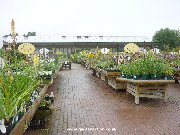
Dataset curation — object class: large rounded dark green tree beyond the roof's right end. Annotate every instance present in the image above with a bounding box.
[153,28,180,50]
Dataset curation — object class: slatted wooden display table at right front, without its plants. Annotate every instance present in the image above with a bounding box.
[126,79,175,104]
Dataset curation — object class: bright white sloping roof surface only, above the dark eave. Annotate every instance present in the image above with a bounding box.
[4,36,150,43]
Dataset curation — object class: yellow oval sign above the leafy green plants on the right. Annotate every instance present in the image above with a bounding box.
[124,43,139,54]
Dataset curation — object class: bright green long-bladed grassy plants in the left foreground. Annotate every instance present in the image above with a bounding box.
[0,67,40,120]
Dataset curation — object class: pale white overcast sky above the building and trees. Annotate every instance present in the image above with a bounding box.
[0,0,180,38]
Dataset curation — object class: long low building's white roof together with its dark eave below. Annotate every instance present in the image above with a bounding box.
[4,36,155,48]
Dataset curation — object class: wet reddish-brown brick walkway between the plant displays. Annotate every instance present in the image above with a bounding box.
[44,64,180,135]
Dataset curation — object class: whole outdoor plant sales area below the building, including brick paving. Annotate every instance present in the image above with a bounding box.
[0,21,180,135]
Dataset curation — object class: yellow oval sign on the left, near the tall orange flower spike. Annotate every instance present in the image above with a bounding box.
[18,43,35,54]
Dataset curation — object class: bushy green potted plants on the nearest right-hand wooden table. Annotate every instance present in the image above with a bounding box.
[120,53,173,75]
